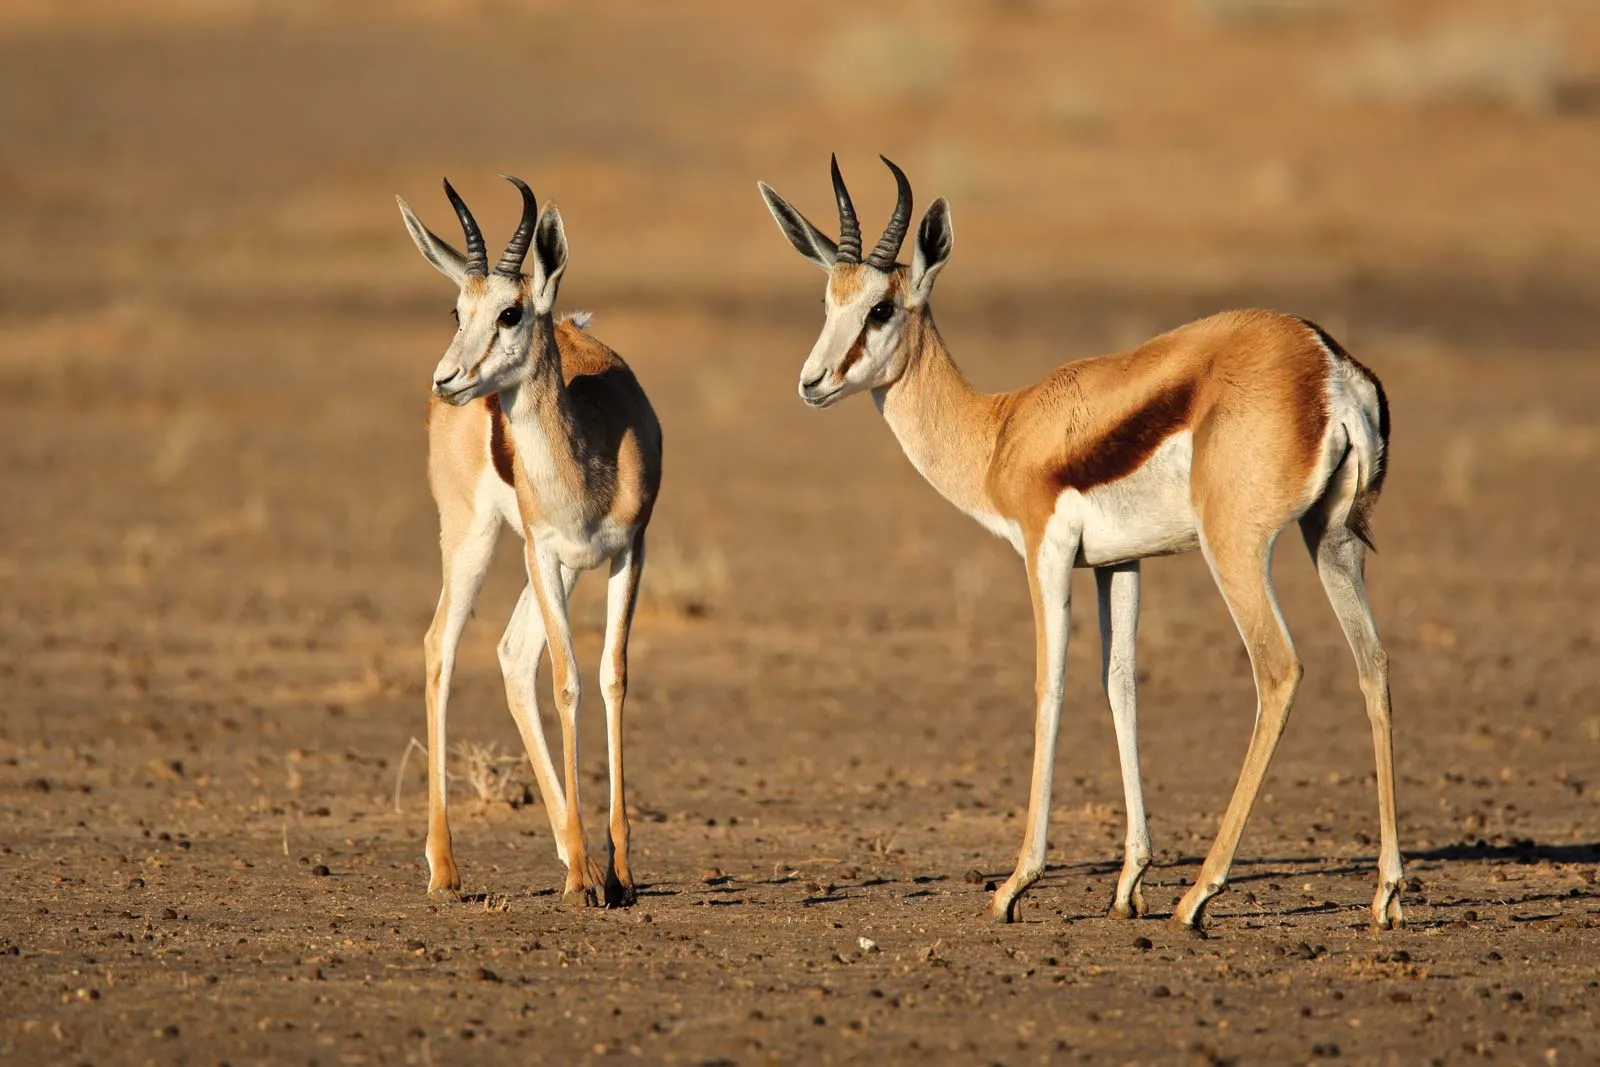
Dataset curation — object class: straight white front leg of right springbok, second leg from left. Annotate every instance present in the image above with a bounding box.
[1094,560,1150,918]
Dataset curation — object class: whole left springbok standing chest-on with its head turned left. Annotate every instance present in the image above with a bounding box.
[397,178,661,905]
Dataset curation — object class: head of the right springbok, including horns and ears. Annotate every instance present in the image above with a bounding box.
[757,157,954,408]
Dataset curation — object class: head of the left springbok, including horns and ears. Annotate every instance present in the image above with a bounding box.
[395,174,566,406]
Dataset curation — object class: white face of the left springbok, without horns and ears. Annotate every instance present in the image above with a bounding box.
[434,274,536,406]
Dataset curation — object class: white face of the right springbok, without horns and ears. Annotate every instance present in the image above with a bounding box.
[800,264,906,408]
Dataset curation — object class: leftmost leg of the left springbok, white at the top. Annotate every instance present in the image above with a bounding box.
[422,509,499,897]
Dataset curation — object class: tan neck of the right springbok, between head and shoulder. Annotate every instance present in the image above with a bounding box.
[872,310,997,514]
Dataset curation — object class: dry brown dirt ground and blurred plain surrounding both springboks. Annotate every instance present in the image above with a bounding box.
[0,0,1600,1065]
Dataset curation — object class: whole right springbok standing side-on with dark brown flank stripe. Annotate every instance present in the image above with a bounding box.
[758,158,1402,928]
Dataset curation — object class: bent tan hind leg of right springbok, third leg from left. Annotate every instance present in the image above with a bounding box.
[1173,531,1304,926]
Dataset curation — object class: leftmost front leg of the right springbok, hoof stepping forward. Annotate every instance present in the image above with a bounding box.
[989,536,1078,923]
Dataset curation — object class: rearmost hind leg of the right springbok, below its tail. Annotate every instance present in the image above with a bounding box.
[1301,517,1405,929]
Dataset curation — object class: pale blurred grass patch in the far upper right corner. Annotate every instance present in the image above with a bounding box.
[1326,22,1581,115]
